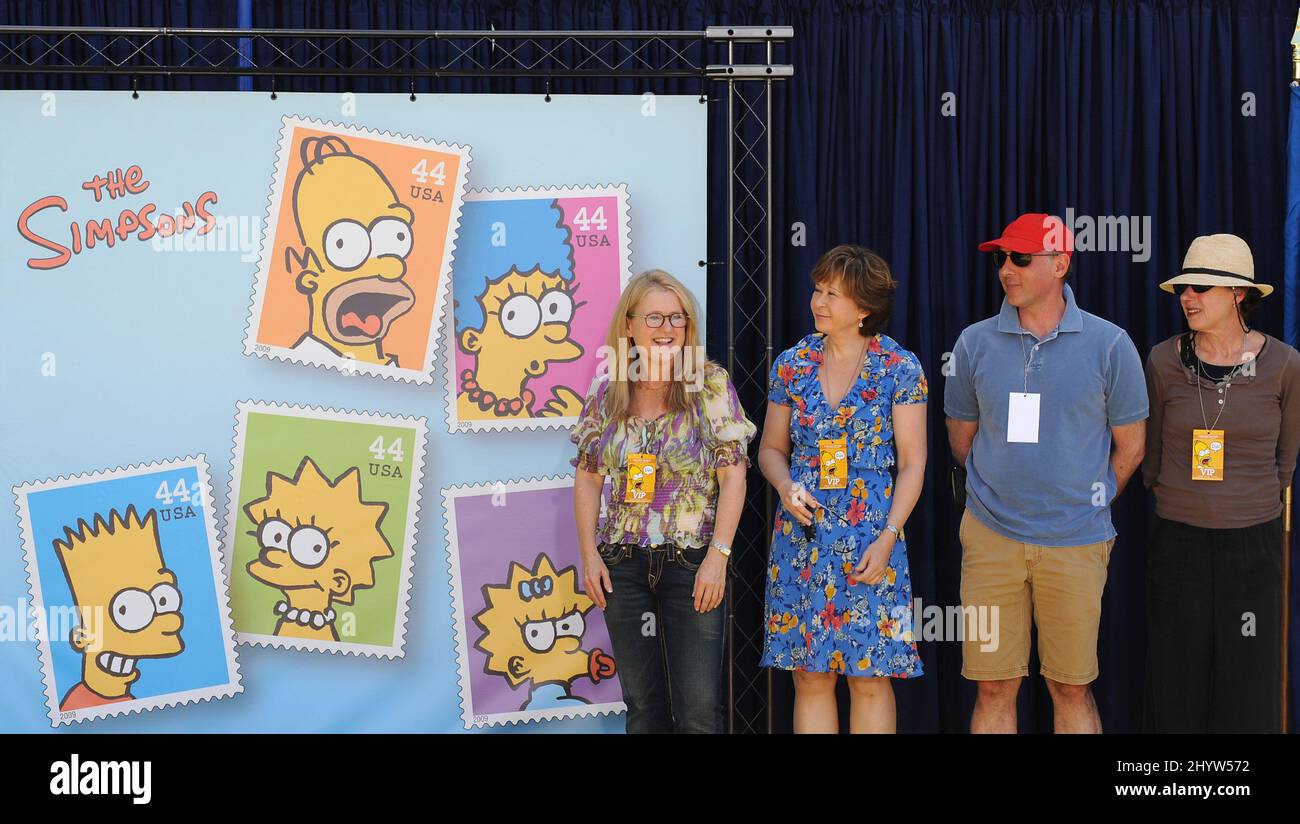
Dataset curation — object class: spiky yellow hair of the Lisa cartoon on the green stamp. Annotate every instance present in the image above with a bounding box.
[244,456,393,603]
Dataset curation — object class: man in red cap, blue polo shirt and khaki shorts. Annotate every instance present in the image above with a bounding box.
[944,214,1148,733]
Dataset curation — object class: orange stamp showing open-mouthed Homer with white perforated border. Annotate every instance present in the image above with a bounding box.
[244,117,469,383]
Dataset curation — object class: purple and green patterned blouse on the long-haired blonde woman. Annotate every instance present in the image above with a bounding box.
[569,363,758,547]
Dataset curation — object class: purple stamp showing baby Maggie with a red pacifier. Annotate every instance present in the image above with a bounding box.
[442,477,627,729]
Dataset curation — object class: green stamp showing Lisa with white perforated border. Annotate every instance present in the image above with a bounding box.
[224,402,428,658]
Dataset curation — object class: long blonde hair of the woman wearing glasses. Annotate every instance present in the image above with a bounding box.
[605,269,707,421]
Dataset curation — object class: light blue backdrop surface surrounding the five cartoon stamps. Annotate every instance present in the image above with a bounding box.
[0,92,706,732]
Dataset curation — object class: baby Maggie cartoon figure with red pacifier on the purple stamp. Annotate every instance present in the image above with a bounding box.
[475,552,615,710]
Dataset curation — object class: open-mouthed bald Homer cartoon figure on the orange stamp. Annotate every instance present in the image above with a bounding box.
[285,135,415,367]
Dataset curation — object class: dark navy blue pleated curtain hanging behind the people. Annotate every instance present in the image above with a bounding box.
[0,0,1300,732]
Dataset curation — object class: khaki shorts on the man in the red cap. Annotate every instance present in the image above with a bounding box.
[959,511,1115,684]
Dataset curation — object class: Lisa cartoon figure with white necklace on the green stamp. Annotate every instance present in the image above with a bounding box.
[244,456,393,641]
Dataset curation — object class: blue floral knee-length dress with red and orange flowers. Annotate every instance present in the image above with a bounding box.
[762,333,930,678]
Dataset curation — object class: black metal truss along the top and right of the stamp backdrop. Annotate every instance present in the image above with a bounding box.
[0,26,794,733]
